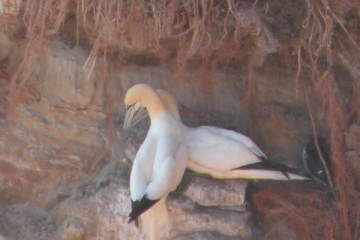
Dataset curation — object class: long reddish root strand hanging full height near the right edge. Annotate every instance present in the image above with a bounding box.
[295,0,359,240]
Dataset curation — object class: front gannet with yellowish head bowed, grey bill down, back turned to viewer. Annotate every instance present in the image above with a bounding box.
[124,84,187,227]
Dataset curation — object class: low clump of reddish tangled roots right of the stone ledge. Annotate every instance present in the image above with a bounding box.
[252,188,339,240]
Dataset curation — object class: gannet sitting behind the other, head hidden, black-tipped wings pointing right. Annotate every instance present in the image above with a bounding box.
[156,89,308,180]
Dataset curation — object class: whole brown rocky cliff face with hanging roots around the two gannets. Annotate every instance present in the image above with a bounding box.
[0,0,360,240]
